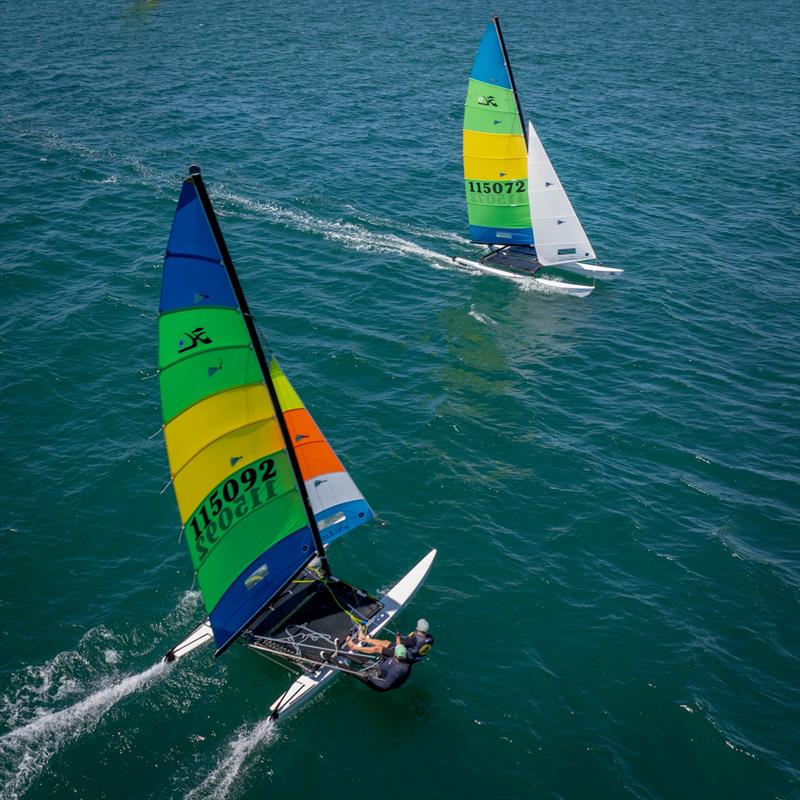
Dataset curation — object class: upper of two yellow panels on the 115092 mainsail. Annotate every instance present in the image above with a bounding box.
[164,383,275,478]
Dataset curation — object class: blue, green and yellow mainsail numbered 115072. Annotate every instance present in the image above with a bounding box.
[464,17,533,244]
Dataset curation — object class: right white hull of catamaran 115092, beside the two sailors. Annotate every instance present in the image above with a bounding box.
[262,550,436,719]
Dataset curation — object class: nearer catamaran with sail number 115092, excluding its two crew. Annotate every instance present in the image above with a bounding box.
[153,166,436,717]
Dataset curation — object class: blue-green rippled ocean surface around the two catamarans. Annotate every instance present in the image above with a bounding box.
[0,0,800,800]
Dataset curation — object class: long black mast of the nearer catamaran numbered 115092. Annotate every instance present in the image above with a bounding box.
[188,164,331,580]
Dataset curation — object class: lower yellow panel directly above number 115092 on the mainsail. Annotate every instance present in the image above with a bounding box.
[173,418,284,524]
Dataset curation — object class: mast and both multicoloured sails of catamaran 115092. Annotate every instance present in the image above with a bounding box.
[158,168,372,653]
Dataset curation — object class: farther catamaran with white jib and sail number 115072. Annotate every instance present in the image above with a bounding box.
[452,17,623,297]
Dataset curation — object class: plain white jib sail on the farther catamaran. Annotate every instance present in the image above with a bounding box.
[528,121,596,266]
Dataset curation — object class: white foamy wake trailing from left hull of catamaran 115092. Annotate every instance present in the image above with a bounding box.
[0,663,168,798]
